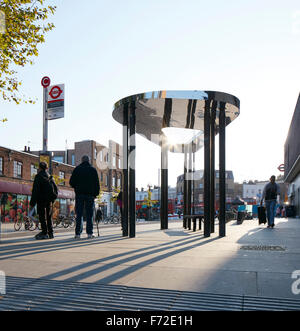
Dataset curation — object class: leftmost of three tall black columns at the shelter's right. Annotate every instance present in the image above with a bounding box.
[204,100,211,237]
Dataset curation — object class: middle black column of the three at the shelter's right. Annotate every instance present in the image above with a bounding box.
[210,101,217,233]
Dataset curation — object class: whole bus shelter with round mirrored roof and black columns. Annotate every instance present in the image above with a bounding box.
[112,90,240,237]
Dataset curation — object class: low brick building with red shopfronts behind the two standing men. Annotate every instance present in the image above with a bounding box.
[0,146,75,226]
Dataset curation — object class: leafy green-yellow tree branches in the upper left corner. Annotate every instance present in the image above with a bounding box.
[0,0,56,109]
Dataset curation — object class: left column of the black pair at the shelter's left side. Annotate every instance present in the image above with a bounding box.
[122,103,128,237]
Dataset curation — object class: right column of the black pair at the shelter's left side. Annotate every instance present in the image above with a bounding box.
[128,101,136,238]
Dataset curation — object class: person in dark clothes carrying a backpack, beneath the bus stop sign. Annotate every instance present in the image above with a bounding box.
[30,162,58,240]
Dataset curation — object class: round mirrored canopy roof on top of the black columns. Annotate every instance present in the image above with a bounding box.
[112,90,240,153]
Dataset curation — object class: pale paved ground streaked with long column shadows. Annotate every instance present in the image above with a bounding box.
[0,218,300,310]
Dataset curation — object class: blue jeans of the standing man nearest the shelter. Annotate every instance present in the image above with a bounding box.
[75,194,94,235]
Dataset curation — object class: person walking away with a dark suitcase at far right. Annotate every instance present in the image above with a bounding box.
[261,176,280,228]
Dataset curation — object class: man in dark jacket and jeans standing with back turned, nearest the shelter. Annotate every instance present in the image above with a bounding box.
[70,155,100,239]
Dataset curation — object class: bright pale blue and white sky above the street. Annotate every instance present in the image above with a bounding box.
[0,0,300,187]
